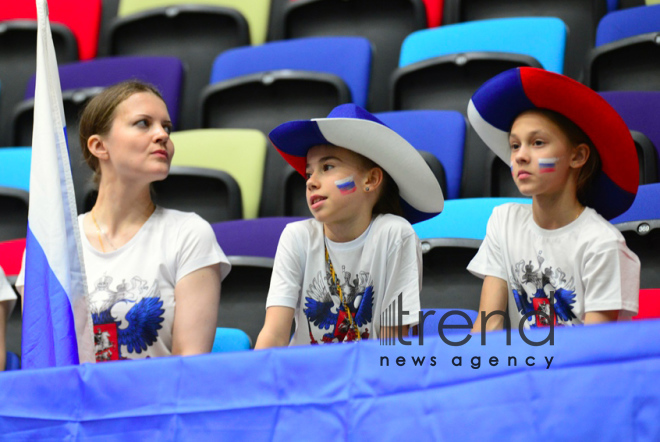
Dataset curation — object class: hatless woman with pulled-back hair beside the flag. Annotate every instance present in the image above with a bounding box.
[19,81,230,362]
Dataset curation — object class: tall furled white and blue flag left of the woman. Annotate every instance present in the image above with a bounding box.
[21,0,95,368]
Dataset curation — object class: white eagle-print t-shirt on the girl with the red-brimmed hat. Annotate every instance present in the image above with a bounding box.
[467,203,640,328]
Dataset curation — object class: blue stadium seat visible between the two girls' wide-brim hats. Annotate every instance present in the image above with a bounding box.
[376,110,466,200]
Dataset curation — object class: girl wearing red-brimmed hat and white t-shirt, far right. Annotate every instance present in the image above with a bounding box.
[468,68,640,332]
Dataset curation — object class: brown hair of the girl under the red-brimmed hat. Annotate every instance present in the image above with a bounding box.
[535,109,602,206]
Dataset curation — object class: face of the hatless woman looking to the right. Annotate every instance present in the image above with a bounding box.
[101,92,174,182]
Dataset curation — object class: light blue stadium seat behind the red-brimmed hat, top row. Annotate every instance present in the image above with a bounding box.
[390,17,567,114]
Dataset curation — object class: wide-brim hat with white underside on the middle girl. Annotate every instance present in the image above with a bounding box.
[268,104,444,223]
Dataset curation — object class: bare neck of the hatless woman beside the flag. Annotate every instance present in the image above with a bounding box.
[92,176,155,237]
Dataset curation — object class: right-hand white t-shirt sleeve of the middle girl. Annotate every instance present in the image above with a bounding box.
[383,227,422,325]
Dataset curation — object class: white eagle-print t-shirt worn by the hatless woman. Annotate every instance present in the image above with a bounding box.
[17,207,231,362]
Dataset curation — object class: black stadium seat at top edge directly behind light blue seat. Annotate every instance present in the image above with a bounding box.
[444,0,607,80]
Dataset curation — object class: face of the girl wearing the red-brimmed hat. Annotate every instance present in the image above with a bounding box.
[509,111,577,196]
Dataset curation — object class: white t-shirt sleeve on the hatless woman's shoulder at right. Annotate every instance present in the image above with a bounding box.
[175,214,231,282]
